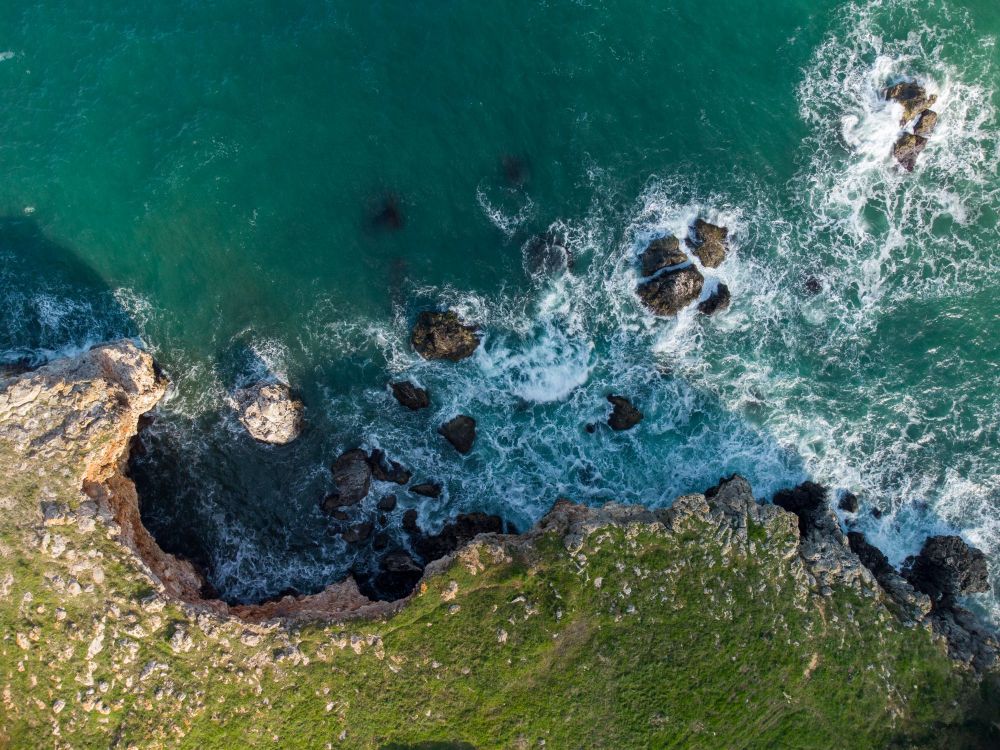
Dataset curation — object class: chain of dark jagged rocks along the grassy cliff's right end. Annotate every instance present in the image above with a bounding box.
[773,482,1000,670]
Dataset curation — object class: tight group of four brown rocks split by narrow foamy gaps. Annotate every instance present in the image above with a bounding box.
[636,219,731,317]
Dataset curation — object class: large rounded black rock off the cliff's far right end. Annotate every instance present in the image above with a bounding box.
[903,536,990,603]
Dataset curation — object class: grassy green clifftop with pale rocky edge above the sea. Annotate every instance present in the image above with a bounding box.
[0,341,998,748]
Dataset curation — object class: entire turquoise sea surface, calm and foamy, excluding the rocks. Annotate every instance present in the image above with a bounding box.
[0,0,1000,612]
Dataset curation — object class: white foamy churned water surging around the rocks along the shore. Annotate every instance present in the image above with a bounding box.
[4,0,1000,621]
